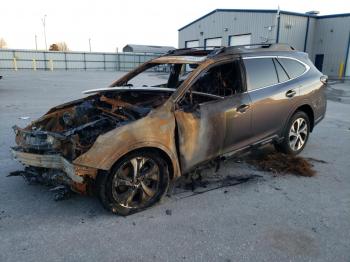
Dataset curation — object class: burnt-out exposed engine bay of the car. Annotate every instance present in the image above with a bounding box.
[13,87,175,161]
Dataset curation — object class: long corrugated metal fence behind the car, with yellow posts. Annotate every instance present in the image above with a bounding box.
[0,49,161,71]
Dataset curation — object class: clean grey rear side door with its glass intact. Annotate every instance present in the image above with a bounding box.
[244,57,299,141]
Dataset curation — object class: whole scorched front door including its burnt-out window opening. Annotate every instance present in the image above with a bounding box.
[175,61,251,173]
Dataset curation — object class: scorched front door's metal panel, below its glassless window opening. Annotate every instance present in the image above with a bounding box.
[175,61,251,172]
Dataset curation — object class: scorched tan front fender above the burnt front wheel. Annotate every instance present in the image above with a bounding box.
[73,100,180,177]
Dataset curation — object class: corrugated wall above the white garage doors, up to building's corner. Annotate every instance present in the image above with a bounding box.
[179,11,307,51]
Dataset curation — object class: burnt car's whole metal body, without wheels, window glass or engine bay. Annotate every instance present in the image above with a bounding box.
[14,44,326,193]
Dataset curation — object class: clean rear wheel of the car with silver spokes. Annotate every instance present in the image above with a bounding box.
[275,111,310,155]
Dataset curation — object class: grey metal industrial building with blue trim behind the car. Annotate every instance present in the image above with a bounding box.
[179,9,350,77]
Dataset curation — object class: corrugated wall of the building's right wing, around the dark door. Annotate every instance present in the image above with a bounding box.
[313,16,350,76]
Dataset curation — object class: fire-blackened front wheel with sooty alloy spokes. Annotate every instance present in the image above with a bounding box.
[96,150,169,216]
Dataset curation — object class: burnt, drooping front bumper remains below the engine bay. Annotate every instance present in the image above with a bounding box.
[12,147,97,193]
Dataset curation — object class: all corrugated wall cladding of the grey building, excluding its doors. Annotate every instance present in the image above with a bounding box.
[179,10,350,76]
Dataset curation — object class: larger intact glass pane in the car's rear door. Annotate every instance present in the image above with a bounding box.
[244,58,278,90]
